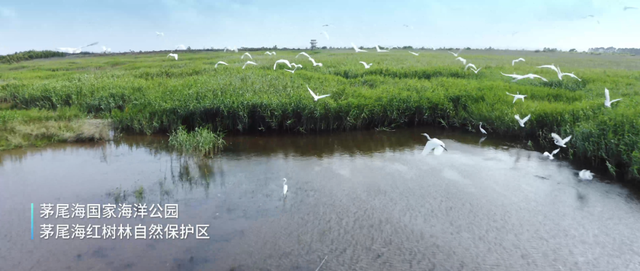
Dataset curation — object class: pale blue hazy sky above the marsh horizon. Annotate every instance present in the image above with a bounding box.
[0,0,640,55]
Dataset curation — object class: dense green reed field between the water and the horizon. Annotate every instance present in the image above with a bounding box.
[0,50,640,183]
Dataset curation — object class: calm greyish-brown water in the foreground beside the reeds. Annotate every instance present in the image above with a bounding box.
[0,128,640,271]
